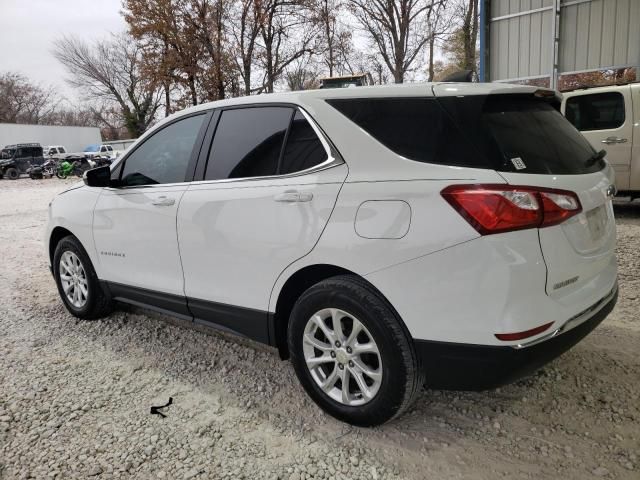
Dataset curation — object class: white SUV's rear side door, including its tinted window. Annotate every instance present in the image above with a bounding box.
[178,106,347,342]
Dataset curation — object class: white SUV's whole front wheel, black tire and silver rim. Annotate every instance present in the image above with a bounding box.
[53,235,113,320]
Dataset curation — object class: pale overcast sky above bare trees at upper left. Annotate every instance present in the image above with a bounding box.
[0,0,127,103]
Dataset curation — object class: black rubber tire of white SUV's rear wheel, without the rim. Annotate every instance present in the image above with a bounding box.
[287,275,424,427]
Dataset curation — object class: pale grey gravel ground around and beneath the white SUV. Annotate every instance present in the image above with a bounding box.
[0,179,640,480]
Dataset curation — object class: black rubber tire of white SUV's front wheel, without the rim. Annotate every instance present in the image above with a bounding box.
[53,235,113,320]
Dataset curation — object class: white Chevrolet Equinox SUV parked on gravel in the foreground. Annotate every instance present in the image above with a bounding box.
[47,84,617,425]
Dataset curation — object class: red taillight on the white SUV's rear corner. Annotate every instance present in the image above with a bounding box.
[441,185,582,235]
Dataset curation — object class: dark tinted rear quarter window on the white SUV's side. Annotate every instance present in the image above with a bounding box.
[327,98,478,167]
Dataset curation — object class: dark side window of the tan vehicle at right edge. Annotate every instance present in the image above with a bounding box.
[565,92,625,132]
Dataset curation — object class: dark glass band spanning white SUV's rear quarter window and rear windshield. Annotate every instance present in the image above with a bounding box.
[328,94,604,175]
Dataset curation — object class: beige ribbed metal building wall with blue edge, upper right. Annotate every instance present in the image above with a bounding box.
[479,0,640,88]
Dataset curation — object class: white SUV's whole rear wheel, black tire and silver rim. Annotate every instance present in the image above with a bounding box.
[288,275,423,426]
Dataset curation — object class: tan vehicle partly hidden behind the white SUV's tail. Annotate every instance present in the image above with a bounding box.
[562,83,640,198]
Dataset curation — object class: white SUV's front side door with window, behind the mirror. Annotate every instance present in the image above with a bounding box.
[93,113,208,308]
